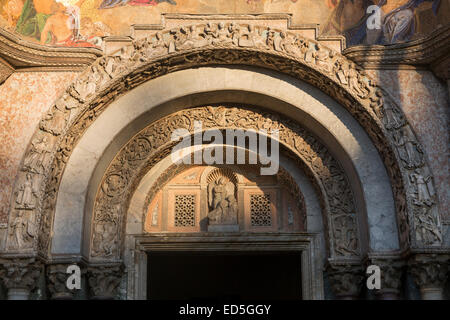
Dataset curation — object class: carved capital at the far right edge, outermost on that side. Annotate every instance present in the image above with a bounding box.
[409,254,449,300]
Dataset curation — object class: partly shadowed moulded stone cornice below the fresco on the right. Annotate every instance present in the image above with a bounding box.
[343,24,450,79]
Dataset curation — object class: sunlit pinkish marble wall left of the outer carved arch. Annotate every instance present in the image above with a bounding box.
[0,72,77,227]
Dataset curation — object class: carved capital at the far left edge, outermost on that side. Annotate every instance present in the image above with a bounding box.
[0,258,43,300]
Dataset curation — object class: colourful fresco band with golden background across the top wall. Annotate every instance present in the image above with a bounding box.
[0,0,450,47]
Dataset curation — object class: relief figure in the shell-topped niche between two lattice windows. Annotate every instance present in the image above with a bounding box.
[208,177,238,224]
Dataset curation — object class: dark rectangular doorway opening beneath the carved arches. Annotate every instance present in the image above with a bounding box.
[147,252,302,300]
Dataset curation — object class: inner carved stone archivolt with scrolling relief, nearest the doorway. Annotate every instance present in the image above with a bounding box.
[91,106,360,260]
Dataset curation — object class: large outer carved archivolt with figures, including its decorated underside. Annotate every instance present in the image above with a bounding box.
[7,22,442,255]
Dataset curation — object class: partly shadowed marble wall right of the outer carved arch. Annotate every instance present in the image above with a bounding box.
[369,70,450,221]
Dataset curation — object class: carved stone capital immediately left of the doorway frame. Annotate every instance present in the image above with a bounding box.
[87,265,124,300]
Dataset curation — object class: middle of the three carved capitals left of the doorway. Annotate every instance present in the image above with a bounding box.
[46,264,81,300]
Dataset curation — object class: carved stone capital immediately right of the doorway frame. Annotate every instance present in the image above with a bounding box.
[326,262,364,300]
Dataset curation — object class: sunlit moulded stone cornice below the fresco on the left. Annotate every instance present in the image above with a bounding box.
[0,28,103,71]
